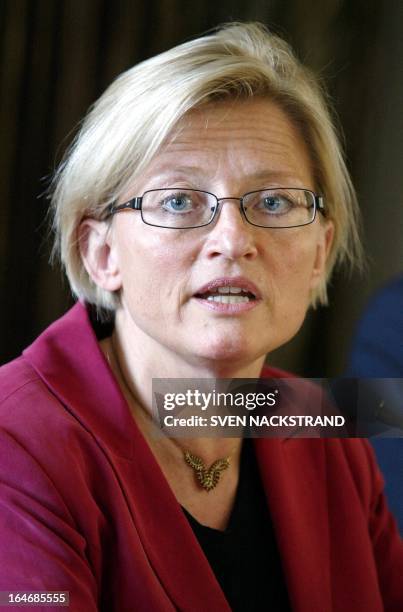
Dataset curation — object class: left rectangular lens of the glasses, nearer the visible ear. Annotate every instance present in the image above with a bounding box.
[142,187,217,229]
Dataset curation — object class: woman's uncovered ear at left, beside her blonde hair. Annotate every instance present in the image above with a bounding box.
[78,219,122,291]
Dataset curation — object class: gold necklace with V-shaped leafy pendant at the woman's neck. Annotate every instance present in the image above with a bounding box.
[106,336,238,492]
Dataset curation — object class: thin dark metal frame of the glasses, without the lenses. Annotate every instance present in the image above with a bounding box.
[104,186,326,230]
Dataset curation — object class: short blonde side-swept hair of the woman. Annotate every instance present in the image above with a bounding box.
[52,23,361,310]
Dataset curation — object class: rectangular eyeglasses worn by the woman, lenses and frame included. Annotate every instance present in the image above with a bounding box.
[105,187,325,229]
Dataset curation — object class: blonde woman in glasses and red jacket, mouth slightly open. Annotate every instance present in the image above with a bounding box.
[0,24,403,612]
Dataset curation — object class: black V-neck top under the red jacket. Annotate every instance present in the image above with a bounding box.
[183,439,291,612]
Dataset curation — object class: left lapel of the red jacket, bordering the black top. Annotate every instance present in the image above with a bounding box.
[110,420,230,612]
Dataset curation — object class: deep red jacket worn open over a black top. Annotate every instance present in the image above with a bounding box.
[0,304,403,612]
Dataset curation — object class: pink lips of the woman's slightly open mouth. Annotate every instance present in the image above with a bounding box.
[193,276,262,314]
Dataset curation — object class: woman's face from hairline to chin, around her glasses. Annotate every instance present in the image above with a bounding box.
[97,100,332,364]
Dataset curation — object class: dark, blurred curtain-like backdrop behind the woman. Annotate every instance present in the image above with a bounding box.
[0,0,403,376]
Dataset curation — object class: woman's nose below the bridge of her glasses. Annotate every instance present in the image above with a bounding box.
[205,198,257,260]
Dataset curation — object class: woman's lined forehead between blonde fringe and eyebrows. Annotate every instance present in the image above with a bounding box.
[134,99,314,188]
